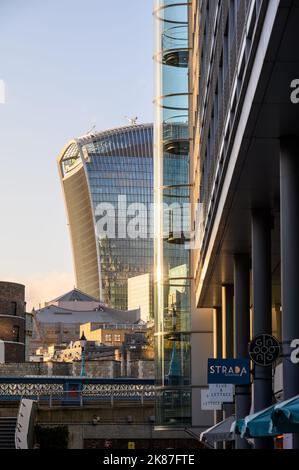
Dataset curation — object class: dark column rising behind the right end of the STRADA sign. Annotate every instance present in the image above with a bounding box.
[234,254,250,449]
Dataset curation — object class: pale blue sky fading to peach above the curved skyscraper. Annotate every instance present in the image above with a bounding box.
[0,0,153,309]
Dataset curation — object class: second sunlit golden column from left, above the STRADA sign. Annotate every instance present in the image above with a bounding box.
[222,284,234,359]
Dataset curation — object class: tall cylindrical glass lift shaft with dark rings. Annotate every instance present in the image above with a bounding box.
[154,0,191,428]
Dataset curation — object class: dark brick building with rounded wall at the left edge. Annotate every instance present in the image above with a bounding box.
[0,281,25,362]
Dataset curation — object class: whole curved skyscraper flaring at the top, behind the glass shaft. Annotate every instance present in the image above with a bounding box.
[58,124,153,310]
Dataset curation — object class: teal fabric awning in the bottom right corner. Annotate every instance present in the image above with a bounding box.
[232,395,299,438]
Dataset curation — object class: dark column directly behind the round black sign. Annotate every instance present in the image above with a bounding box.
[251,209,273,449]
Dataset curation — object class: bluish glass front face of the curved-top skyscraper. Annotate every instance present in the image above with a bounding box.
[61,125,153,309]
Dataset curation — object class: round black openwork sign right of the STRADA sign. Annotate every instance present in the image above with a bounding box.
[249,334,280,367]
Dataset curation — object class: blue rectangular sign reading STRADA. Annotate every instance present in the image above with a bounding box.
[208,359,250,385]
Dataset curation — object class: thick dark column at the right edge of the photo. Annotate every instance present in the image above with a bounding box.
[280,137,299,448]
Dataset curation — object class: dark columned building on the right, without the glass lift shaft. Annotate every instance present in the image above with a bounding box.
[189,0,299,448]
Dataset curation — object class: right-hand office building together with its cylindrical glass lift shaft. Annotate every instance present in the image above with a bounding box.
[154,0,299,448]
